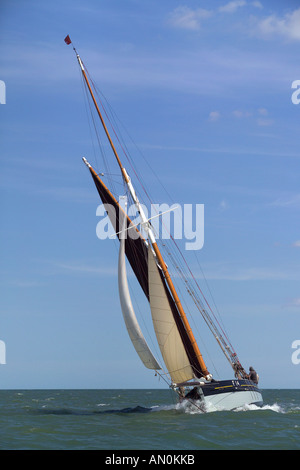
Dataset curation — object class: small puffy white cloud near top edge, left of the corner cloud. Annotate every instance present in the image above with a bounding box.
[169,6,212,30]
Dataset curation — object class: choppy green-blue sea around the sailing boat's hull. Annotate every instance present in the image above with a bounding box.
[0,390,300,452]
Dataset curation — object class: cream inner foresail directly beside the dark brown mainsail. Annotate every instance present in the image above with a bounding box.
[148,246,194,383]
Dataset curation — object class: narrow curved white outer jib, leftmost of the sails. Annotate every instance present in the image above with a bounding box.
[118,238,161,370]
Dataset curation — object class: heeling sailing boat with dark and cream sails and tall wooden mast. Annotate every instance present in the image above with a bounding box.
[65,36,263,410]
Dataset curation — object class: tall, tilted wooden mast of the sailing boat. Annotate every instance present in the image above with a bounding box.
[70,41,211,380]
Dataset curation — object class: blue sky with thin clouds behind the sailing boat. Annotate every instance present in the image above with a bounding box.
[0,0,300,388]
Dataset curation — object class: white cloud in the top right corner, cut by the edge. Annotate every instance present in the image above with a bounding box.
[258,8,300,40]
